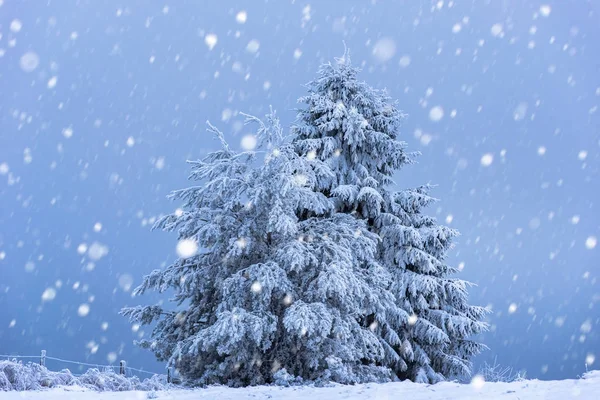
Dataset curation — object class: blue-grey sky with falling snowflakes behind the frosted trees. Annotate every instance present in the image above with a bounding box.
[0,0,600,379]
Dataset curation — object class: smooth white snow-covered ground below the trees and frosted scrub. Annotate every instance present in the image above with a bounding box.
[0,371,600,400]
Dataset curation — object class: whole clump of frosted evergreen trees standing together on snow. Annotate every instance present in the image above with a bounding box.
[122,54,487,386]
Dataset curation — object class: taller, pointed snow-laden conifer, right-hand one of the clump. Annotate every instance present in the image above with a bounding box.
[293,52,487,382]
